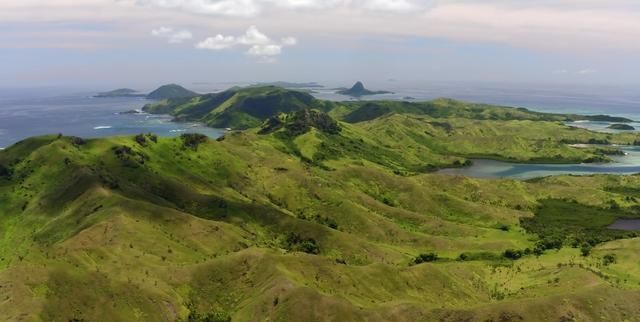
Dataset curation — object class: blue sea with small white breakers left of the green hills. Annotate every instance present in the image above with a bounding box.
[0,93,223,148]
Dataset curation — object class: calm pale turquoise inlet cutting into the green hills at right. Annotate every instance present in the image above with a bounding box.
[438,147,640,179]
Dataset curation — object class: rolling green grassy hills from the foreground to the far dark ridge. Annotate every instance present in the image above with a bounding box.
[0,91,640,322]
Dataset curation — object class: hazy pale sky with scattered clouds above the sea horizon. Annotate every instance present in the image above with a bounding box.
[0,0,640,88]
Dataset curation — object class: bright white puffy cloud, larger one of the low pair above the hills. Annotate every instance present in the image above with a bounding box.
[196,26,297,62]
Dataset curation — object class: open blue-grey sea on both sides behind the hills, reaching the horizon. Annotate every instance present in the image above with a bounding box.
[0,81,640,152]
